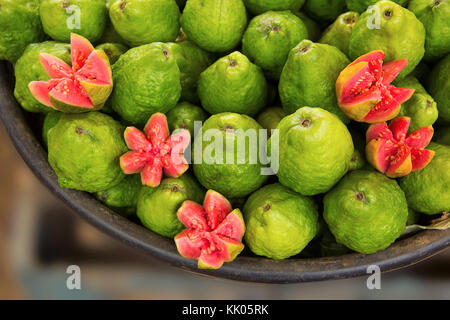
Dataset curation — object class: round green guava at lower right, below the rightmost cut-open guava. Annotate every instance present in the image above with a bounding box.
[323,170,408,254]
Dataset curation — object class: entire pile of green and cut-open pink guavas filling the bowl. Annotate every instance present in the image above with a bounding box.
[0,0,450,269]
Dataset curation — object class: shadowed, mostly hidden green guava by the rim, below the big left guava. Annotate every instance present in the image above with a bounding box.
[95,174,142,216]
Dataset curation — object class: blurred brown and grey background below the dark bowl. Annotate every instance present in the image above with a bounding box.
[0,124,450,300]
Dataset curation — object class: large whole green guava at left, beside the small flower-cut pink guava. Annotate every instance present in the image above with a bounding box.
[48,112,128,193]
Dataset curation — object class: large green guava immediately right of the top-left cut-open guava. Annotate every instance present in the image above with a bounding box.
[111,42,181,125]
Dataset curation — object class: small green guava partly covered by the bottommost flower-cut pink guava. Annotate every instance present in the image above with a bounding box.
[136,174,204,238]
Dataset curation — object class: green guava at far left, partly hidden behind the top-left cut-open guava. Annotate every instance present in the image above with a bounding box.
[14,41,70,113]
